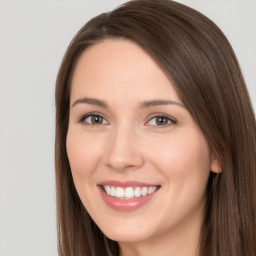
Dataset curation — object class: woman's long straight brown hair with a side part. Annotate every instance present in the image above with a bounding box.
[55,0,256,256]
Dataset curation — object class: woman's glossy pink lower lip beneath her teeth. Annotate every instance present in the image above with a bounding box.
[99,187,158,212]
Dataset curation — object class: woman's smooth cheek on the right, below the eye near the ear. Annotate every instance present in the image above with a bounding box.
[148,131,211,198]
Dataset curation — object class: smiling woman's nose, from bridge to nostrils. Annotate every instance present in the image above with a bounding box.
[105,124,144,171]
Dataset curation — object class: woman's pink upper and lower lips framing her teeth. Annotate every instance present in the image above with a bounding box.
[98,180,160,212]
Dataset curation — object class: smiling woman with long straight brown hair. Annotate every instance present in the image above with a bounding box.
[56,0,256,256]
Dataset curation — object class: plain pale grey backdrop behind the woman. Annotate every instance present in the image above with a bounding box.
[0,0,256,256]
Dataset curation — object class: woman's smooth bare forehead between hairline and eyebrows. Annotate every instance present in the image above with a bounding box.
[71,39,177,102]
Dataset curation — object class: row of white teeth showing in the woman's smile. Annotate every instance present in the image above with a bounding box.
[103,185,157,199]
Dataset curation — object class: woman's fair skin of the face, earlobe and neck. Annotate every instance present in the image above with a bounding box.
[66,39,220,256]
